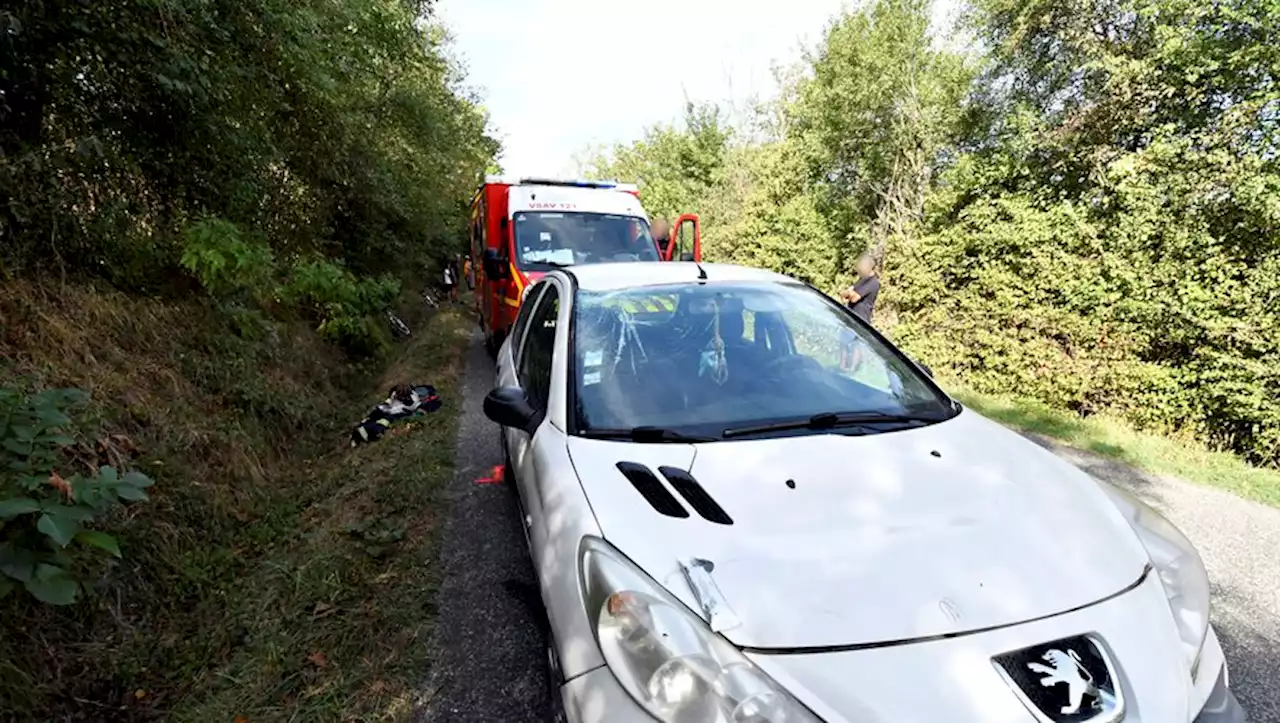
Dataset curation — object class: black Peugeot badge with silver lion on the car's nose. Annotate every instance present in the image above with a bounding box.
[992,635,1124,723]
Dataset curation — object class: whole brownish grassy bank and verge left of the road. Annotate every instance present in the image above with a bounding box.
[0,283,471,723]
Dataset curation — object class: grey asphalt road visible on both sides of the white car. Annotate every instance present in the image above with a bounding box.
[416,335,1280,723]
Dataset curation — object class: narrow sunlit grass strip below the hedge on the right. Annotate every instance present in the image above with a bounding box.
[946,383,1280,507]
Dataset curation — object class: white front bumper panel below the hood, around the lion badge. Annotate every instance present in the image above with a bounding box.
[748,575,1222,723]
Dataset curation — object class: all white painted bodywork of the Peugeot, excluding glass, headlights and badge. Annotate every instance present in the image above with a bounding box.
[495,264,1244,723]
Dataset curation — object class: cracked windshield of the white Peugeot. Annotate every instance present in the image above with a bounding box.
[572,282,955,440]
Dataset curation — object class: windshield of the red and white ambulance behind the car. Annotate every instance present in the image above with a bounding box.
[515,211,658,271]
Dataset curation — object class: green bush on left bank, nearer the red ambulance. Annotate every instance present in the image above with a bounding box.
[282,261,401,356]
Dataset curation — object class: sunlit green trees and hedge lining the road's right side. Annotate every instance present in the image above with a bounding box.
[591,0,1280,466]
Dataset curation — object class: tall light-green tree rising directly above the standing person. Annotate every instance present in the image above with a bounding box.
[794,0,970,266]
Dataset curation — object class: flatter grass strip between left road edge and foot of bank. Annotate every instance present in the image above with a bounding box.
[170,311,470,722]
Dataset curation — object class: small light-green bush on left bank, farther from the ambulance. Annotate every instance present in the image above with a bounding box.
[182,218,275,297]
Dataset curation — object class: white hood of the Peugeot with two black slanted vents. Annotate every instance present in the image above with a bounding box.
[568,411,1147,650]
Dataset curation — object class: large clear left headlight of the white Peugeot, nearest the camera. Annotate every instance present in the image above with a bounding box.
[580,537,819,723]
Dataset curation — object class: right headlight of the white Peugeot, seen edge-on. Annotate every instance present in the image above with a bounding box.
[1100,482,1210,679]
